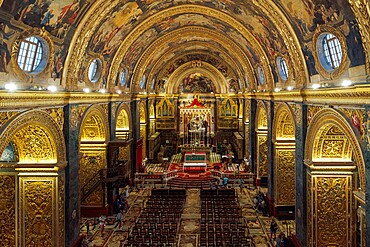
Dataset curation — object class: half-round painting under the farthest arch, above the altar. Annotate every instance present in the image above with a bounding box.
[179,73,215,93]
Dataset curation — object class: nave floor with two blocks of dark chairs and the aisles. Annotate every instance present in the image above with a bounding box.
[81,187,295,247]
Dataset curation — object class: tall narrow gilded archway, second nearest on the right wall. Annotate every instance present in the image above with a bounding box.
[272,103,296,212]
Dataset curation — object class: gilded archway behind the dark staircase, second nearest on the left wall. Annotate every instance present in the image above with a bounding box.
[79,106,109,207]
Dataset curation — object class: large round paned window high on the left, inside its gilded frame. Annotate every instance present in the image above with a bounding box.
[17,36,49,73]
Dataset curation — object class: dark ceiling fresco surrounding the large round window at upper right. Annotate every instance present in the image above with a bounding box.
[277,0,365,68]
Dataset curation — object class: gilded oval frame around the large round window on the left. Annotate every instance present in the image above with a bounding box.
[11,28,55,82]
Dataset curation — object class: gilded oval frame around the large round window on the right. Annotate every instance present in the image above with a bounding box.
[312,25,350,80]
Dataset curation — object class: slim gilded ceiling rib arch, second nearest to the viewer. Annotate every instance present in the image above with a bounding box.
[108,4,273,91]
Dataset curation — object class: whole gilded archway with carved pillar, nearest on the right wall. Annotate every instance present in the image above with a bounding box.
[305,109,365,246]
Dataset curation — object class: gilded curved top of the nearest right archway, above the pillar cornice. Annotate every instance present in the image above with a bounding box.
[304,108,365,188]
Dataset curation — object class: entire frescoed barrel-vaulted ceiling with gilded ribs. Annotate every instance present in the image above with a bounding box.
[0,0,370,93]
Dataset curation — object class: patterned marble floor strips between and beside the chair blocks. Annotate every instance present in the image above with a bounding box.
[80,188,295,247]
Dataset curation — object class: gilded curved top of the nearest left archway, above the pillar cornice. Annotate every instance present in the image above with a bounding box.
[0,110,66,165]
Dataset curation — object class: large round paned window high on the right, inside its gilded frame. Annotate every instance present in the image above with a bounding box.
[317,33,343,71]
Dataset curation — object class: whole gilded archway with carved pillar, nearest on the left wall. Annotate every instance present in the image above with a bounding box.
[0,110,66,246]
